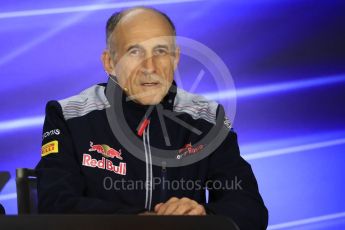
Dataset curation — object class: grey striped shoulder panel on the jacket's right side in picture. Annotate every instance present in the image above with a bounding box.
[173,88,218,124]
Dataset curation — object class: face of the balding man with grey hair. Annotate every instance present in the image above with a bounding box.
[110,10,179,105]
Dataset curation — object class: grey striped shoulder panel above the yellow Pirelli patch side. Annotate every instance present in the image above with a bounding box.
[58,85,110,120]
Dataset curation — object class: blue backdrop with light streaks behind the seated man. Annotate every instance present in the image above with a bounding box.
[0,0,345,229]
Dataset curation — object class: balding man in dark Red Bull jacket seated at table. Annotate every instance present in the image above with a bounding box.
[37,7,268,229]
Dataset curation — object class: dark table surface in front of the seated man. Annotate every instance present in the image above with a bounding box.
[0,215,237,230]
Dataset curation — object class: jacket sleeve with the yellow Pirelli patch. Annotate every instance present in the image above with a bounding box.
[36,101,144,214]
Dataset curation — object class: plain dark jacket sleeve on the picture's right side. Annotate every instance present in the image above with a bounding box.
[205,112,268,230]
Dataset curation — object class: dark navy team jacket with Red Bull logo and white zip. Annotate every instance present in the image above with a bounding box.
[36,82,268,230]
